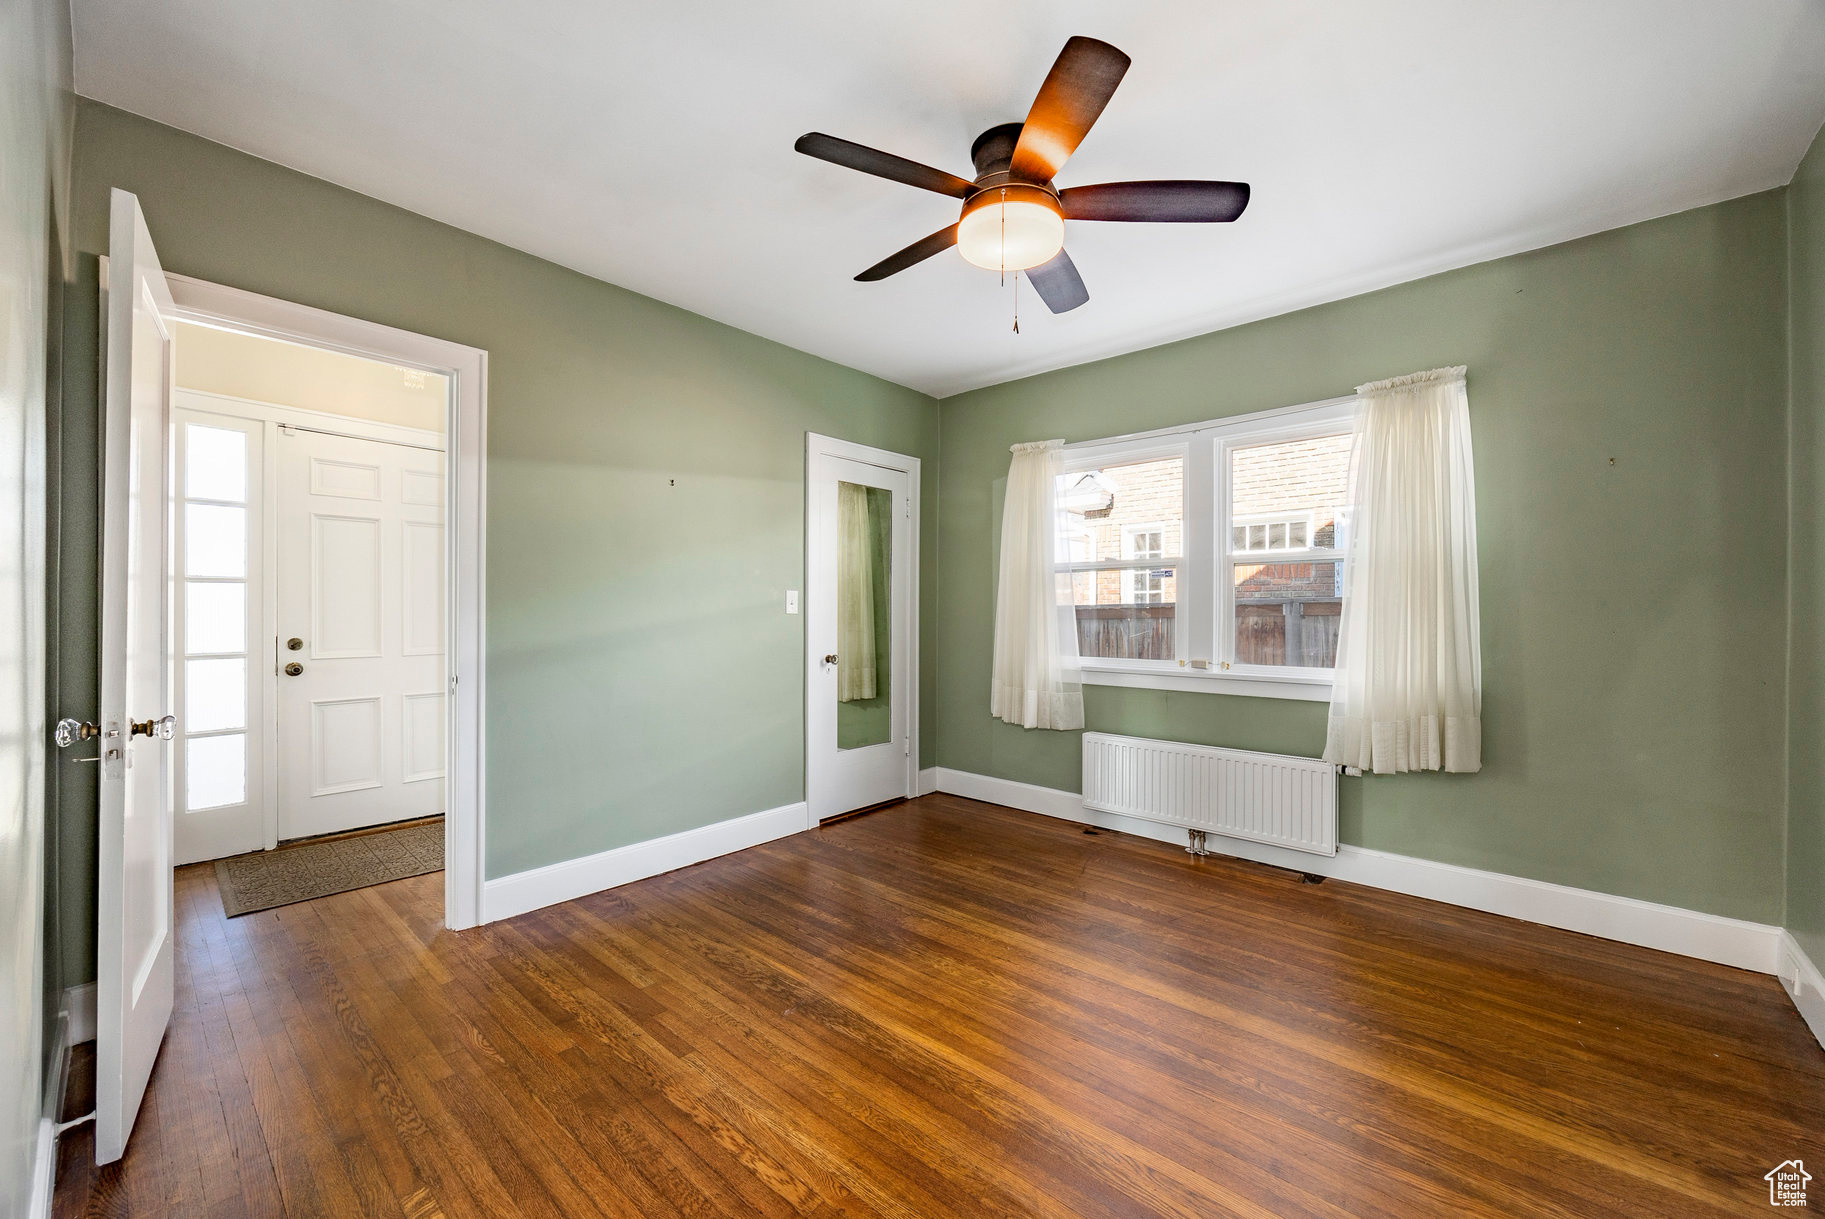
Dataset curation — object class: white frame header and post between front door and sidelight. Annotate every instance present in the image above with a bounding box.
[172,385,449,850]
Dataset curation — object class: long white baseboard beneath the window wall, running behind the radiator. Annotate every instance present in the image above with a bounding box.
[938,766,1781,978]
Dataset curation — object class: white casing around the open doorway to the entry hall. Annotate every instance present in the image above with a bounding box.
[166,274,487,929]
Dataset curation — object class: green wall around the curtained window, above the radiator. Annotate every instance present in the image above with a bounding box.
[938,192,1788,922]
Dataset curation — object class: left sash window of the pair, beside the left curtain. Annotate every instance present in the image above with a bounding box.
[1059,445,1184,661]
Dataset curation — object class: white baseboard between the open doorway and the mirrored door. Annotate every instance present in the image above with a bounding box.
[482,801,808,923]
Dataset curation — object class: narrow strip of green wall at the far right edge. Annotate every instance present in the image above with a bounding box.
[1787,118,1825,962]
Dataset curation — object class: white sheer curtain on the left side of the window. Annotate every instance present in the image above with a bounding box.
[989,440,1084,730]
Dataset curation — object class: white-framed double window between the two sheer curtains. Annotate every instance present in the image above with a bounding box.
[1059,398,1354,699]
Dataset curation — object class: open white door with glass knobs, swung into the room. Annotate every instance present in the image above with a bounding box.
[95,190,175,1164]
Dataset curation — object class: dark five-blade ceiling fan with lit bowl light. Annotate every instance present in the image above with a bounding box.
[792,36,1248,314]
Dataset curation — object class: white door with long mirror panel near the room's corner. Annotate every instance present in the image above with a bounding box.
[805,453,918,819]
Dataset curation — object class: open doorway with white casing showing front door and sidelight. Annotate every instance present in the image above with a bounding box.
[168,276,487,927]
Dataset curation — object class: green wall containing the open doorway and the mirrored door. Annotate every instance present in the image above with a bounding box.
[62,102,938,976]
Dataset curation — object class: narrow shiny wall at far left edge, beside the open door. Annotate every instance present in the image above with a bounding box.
[0,0,71,1219]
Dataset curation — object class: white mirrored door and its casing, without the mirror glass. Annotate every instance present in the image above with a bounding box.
[805,434,920,825]
